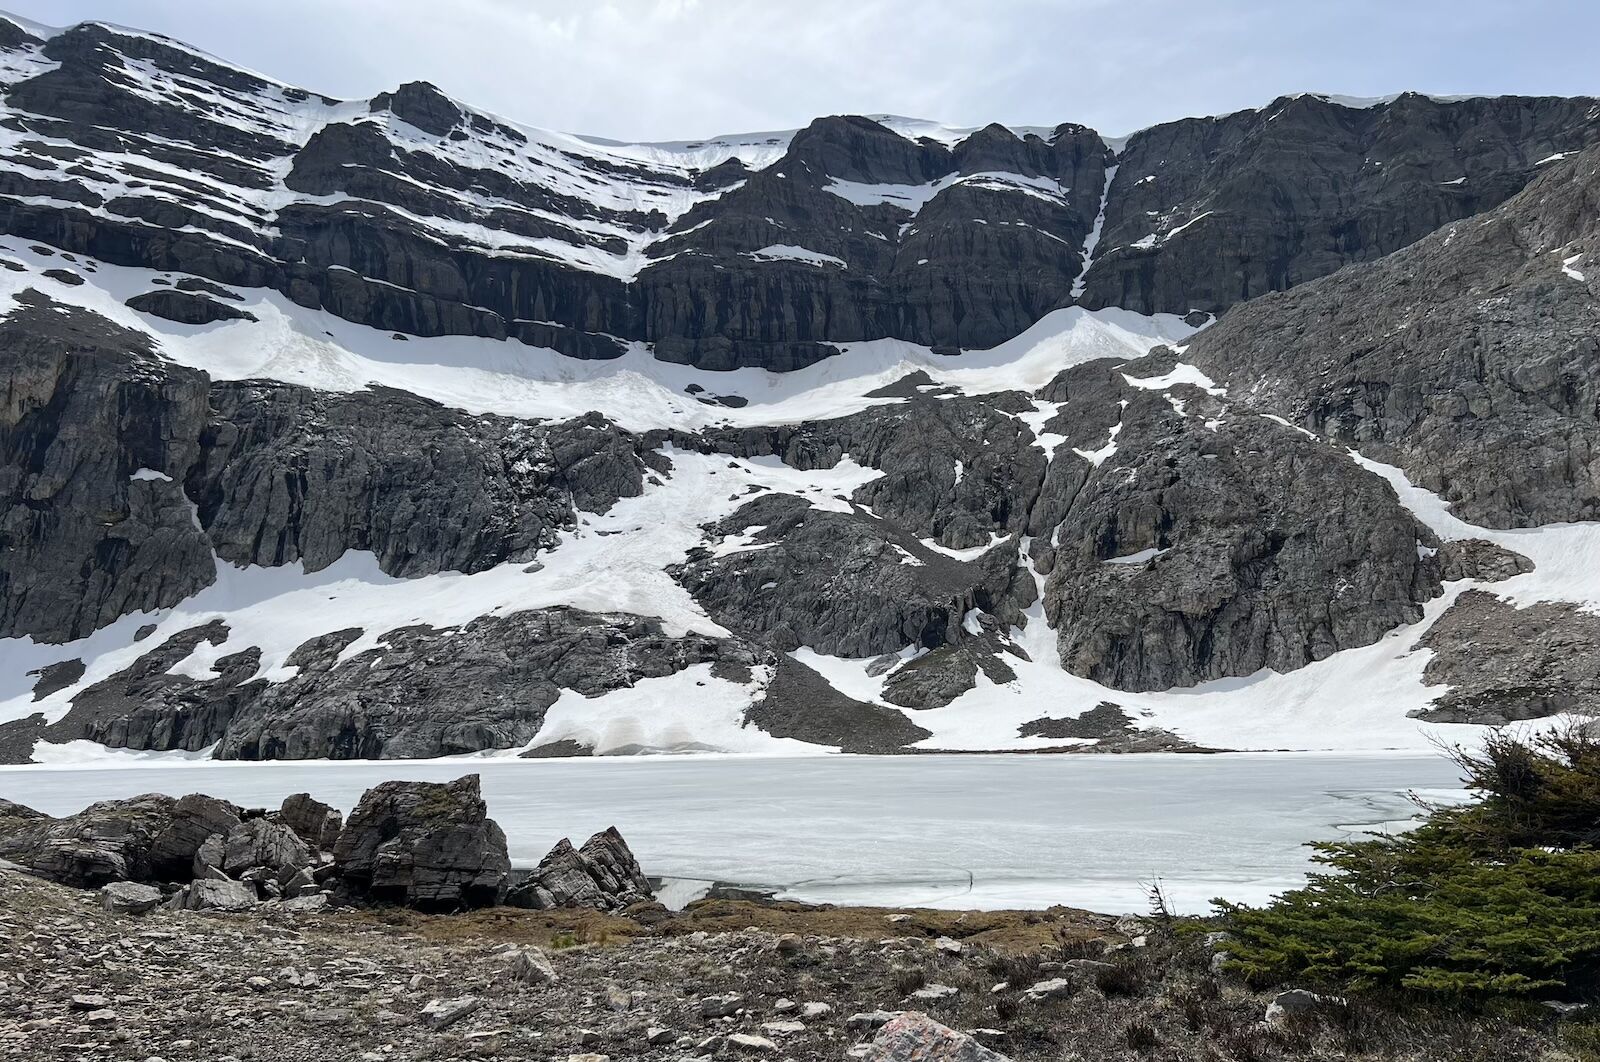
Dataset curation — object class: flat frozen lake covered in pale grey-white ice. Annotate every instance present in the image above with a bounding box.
[0,753,1461,912]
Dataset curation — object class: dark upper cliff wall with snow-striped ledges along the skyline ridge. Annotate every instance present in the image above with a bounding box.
[0,24,1597,369]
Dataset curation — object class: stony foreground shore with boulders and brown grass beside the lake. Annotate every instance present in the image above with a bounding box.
[0,776,1574,1062]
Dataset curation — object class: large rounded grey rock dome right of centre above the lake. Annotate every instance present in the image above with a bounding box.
[1045,356,1440,691]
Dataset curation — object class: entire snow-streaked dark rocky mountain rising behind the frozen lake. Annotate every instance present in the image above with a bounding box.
[0,19,1600,761]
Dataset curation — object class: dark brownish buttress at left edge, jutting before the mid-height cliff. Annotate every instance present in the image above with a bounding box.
[0,291,213,641]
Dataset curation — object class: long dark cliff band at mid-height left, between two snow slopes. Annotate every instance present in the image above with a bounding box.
[0,293,645,641]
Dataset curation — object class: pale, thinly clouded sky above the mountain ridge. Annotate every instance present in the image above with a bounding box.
[12,0,1600,139]
